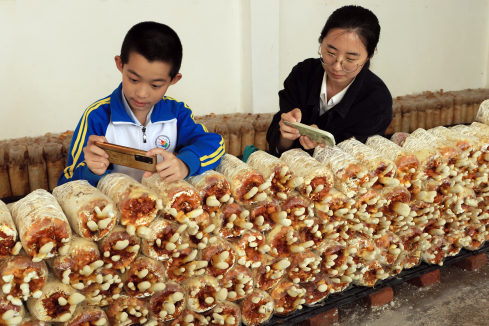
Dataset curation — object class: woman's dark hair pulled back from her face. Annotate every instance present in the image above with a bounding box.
[319,6,380,69]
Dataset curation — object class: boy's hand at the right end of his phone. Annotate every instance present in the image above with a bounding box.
[143,148,190,182]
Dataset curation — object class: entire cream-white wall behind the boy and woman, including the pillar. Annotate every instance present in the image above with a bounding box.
[0,0,489,139]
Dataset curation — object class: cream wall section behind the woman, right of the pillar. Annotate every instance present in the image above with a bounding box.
[280,0,489,96]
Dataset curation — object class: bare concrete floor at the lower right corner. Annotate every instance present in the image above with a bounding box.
[339,255,489,326]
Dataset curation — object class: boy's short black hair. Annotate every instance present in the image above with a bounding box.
[121,22,183,79]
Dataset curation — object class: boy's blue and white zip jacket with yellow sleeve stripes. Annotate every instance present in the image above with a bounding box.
[58,84,224,186]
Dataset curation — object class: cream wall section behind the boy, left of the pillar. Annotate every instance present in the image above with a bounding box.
[0,0,241,139]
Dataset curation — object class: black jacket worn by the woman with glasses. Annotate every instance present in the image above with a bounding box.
[267,59,392,155]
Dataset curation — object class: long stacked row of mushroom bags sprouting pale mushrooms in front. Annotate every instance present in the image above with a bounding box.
[0,101,489,326]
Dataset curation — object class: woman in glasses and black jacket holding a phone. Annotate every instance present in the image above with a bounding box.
[267,6,392,155]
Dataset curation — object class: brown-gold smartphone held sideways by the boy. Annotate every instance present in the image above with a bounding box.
[95,142,156,172]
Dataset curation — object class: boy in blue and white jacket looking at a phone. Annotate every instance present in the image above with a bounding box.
[58,22,224,186]
